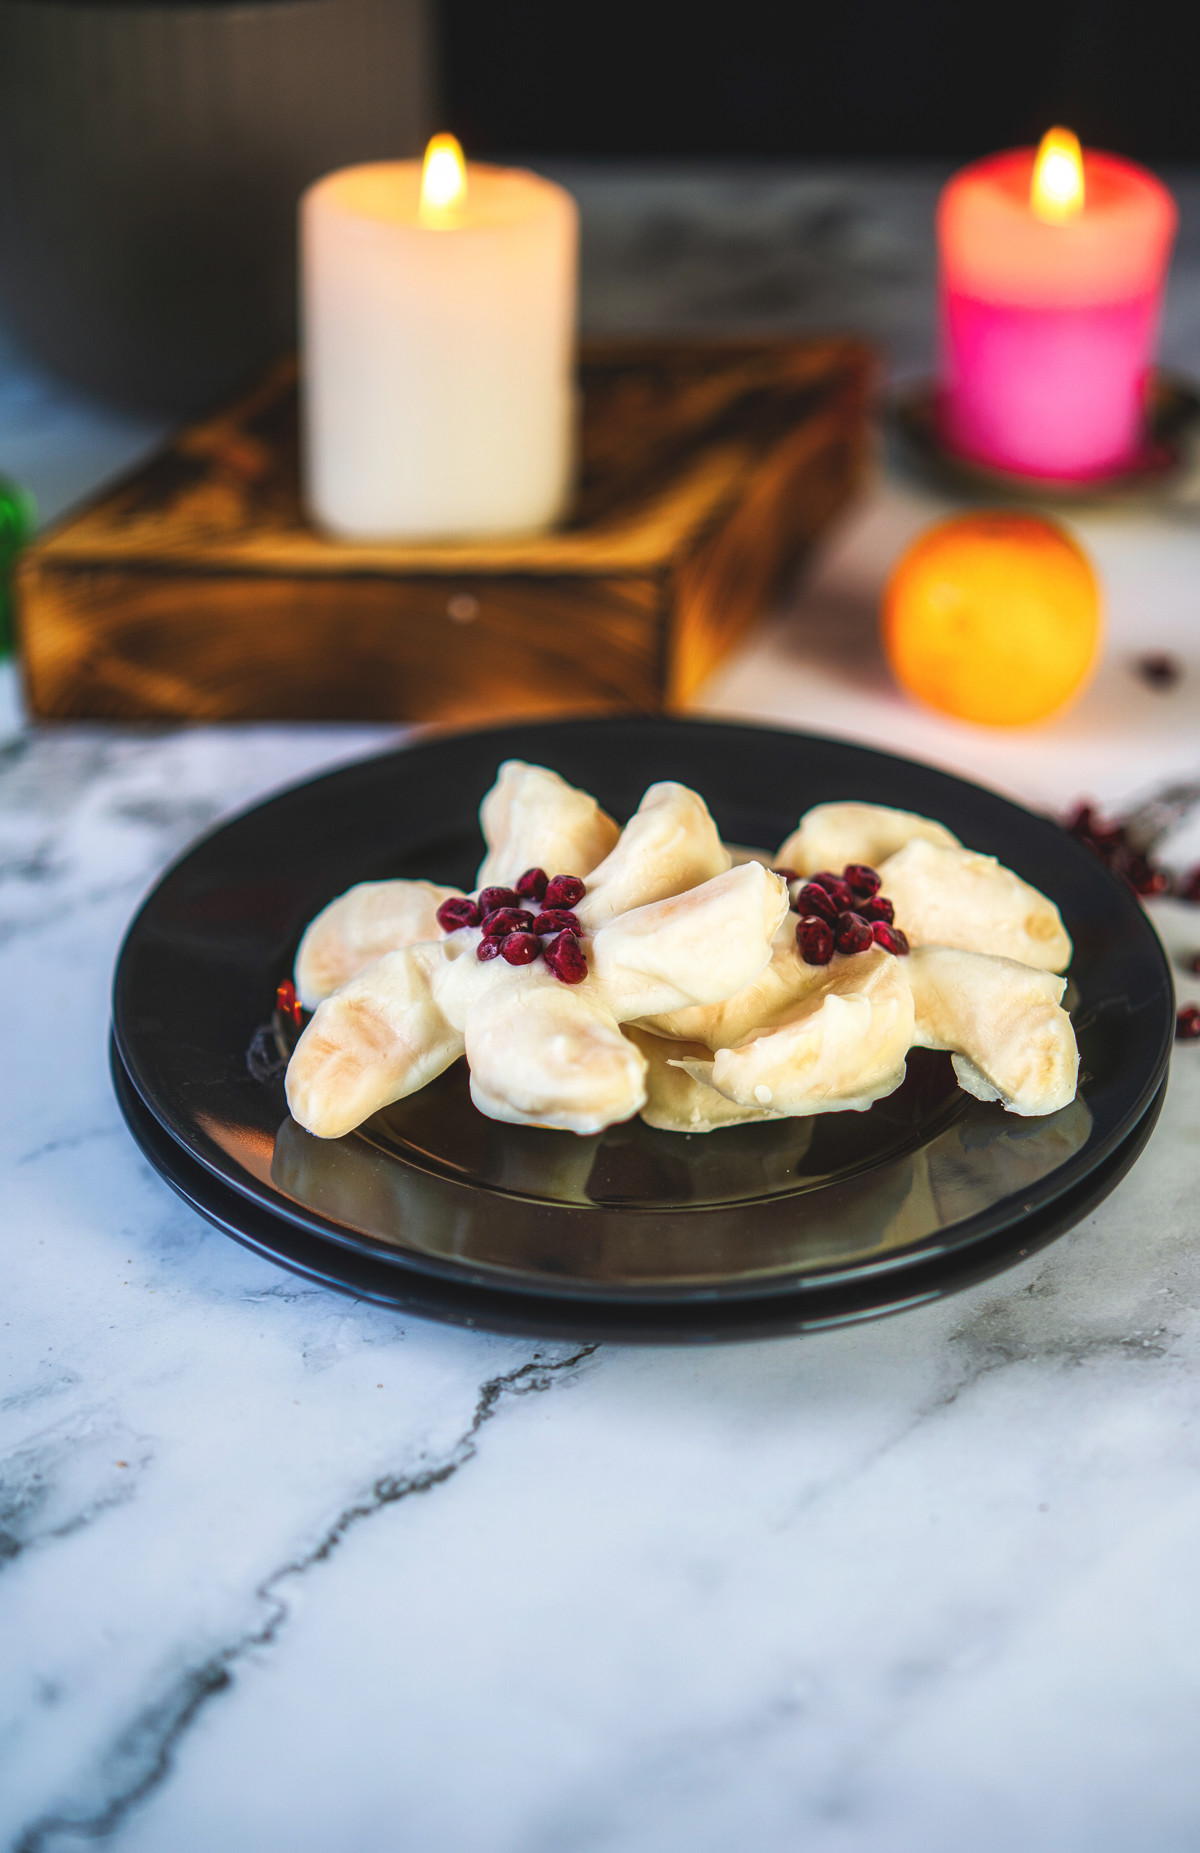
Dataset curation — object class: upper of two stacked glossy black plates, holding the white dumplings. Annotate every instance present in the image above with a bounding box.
[113,717,1174,1330]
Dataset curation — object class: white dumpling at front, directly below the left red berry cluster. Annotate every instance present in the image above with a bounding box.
[467,967,646,1134]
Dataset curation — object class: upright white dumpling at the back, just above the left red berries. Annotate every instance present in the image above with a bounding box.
[476,760,620,888]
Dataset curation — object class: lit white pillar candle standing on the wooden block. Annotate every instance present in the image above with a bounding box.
[300,137,578,541]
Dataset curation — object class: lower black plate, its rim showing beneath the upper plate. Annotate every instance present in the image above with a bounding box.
[109,1045,1167,1345]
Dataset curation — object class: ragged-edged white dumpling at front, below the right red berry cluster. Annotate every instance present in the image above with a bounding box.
[687,949,913,1117]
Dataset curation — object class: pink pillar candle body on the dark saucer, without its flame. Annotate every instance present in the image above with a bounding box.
[937,148,1178,482]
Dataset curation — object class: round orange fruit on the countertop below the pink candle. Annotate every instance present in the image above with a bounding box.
[883,511,1100,726]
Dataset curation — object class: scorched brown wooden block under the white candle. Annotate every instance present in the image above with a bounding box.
[17,339,874,723]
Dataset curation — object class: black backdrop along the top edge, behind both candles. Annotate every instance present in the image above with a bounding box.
[439,0,1200,161]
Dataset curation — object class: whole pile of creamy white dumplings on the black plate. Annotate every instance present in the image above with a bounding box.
[287,760,1080,1140]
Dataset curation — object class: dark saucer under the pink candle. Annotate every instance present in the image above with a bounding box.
[887,371,1200,508]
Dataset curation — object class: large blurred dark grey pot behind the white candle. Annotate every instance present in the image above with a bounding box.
[0,0,433,411]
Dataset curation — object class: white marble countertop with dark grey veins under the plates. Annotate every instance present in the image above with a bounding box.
[0,170,1200,1853]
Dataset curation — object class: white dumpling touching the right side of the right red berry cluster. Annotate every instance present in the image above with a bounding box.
[880,841,1070,971]
